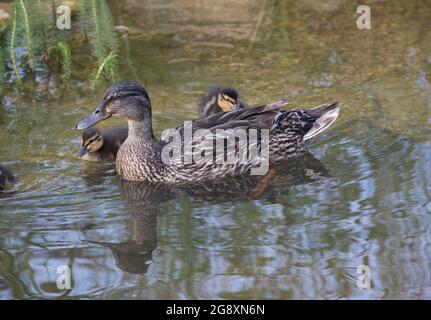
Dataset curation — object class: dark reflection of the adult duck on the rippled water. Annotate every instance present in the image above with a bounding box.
[85,153,329,274]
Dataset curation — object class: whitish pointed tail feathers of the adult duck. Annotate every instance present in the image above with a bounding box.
[304,102,340,141]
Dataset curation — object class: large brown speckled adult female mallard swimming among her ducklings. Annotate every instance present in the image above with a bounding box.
[76,81,339,183]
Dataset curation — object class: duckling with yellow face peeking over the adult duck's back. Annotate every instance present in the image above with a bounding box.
[198,86,246,116]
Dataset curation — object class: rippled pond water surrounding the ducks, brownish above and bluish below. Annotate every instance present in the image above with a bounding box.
[0,0,431,299]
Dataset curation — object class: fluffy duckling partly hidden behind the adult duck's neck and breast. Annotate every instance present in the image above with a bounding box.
[78,127,128,163]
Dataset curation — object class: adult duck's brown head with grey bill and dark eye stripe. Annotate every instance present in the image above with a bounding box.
[76,81,151,130]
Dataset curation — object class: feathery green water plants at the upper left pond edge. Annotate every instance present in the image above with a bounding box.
[0,0,118,89]
